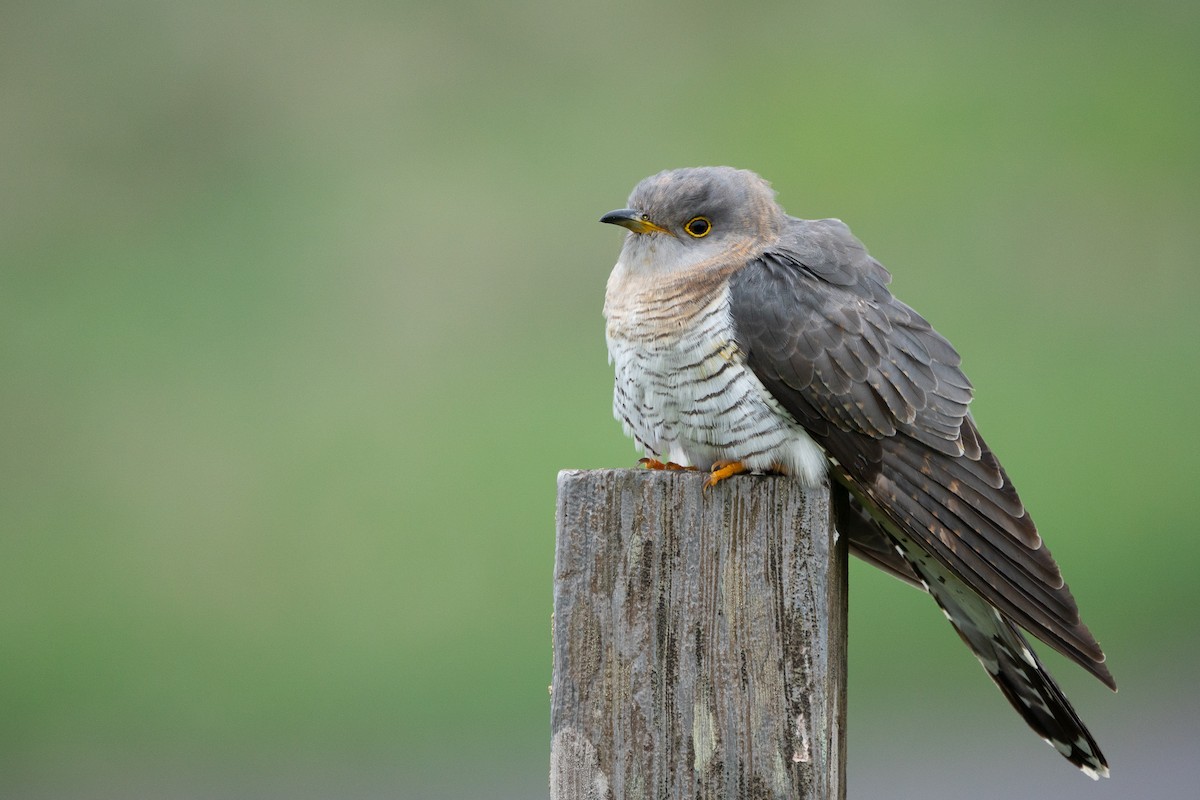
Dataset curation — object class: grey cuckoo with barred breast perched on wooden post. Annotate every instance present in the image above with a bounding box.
[600,167,1116,780]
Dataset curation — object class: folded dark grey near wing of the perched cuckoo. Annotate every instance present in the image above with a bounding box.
[731,219,1115,687]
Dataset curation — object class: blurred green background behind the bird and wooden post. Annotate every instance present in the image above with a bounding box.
[0,0,1200,800]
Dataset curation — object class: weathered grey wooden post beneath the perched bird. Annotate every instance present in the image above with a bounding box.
[550,469,846,800]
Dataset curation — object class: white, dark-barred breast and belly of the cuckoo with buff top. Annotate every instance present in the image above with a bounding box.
[605,264,828,486]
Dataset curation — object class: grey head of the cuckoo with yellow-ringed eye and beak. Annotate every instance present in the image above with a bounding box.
[600,167,787,271]
